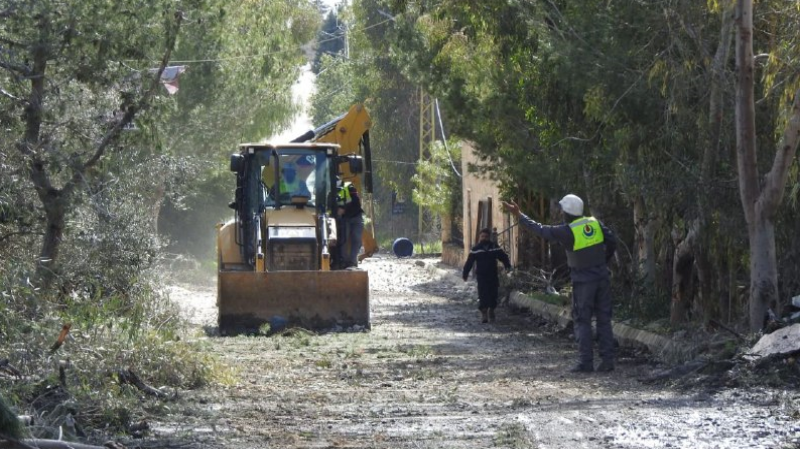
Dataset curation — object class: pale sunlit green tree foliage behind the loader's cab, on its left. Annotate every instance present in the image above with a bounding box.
[158,0,320,259]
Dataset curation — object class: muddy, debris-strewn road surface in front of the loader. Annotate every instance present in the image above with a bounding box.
[155,256,800,448]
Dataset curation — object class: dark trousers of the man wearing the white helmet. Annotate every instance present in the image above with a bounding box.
[572,278,615,366]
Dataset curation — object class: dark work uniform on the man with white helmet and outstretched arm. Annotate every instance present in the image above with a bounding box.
[520,214,617,368]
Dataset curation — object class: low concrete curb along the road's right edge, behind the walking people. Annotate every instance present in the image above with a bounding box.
[424,263,672,354]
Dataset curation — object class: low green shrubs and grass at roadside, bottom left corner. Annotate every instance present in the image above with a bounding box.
[0,258,227,431]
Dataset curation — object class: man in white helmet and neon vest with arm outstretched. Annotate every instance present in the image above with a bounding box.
[503,194,617,372]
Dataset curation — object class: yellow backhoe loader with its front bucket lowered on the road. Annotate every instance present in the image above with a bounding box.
[217,105,374,335]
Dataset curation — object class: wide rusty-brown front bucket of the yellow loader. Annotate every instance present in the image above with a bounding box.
[217,270,370,335]
